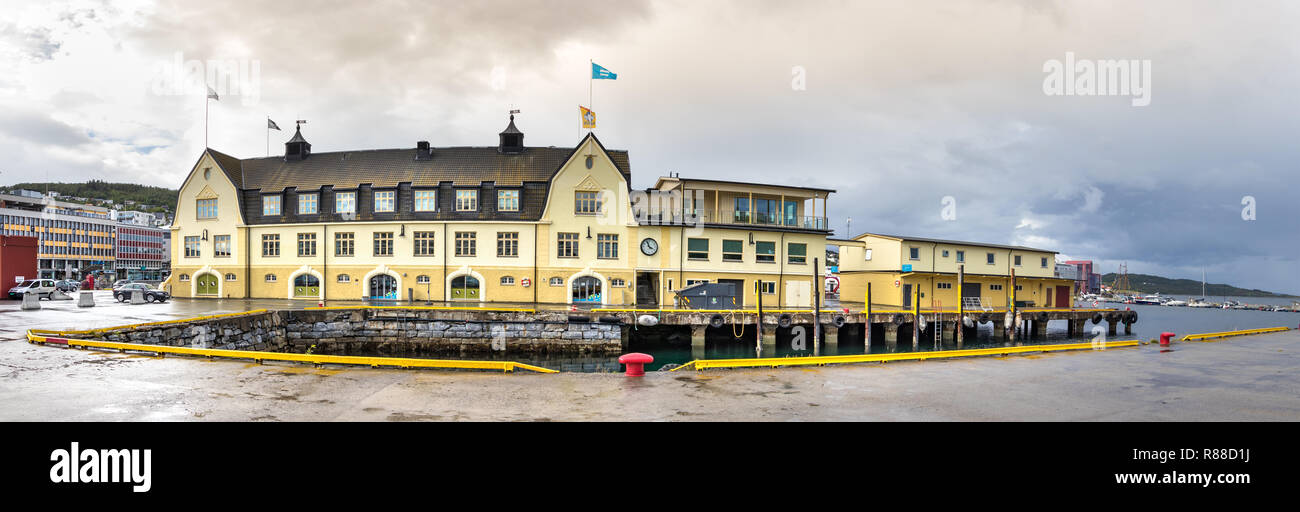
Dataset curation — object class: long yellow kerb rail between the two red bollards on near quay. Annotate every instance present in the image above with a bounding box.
[670,339,1140,372]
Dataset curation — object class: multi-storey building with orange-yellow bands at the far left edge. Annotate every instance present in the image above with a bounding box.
[0,194,116,279]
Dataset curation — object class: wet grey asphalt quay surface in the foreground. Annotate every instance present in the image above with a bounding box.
[0,291,1300,421]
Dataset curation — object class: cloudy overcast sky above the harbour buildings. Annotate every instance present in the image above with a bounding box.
[0,0,1300,294]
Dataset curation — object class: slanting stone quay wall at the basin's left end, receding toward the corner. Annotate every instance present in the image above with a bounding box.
[88,311,286,352]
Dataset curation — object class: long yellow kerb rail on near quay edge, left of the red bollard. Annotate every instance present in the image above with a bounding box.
[27,331,559,373]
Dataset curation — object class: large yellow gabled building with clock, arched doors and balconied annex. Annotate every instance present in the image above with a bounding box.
[166,116,831,307]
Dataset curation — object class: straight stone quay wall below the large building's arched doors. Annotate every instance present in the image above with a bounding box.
[282,309,625,356]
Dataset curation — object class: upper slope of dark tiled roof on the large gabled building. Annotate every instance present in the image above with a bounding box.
[232,147,631,192]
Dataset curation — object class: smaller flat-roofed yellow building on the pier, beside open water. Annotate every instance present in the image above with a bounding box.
[829,233,1074,309]
